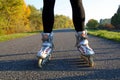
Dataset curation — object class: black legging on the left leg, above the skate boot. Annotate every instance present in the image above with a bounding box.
[42,0,55,33]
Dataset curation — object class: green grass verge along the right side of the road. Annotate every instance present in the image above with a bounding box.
[88,30,120,42]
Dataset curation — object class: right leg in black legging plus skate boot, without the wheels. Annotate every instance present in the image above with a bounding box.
[70,0,94,55]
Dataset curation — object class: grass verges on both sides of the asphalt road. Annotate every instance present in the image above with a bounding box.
[0,29,120,42]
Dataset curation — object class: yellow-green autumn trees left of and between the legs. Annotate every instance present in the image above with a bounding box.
[0,0,73,35]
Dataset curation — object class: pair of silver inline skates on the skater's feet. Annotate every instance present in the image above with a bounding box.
[37,31,94,68]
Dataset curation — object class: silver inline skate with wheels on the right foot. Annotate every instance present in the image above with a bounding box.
[75,31,95,67]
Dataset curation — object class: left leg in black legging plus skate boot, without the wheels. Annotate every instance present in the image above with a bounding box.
[37,0,55,58]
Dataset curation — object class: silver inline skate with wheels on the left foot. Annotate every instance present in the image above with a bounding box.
[37,33,54,68]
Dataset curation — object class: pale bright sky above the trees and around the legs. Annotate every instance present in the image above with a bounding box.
[25,0,120,22]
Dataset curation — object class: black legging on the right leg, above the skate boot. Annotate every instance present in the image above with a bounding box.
[70,0,85,32]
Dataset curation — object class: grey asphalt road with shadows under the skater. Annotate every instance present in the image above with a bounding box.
[0,31,120,80]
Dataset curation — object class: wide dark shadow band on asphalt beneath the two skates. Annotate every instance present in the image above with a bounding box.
[0,58,91,71]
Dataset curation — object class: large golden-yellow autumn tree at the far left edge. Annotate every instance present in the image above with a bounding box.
[0,0,31,34]
